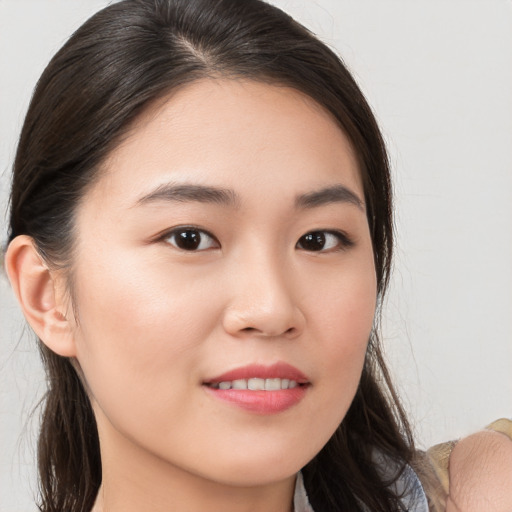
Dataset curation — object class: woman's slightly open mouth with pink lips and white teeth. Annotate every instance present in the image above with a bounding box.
[202,363,311,414]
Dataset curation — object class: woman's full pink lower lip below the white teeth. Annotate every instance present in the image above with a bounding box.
[203,385,308,414]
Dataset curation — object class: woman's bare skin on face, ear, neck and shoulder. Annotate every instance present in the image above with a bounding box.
[5,80,512,512]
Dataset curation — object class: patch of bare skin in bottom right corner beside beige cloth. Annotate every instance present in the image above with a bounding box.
[446,430,512,512]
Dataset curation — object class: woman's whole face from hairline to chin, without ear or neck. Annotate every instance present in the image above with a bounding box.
[69,79,376,485]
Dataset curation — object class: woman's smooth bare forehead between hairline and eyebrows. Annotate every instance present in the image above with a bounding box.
[93,79,362,207]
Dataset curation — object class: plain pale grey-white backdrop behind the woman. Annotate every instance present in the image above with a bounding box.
[0,0,512,512]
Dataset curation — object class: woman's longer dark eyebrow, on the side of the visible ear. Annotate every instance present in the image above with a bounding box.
[134,183,239,207]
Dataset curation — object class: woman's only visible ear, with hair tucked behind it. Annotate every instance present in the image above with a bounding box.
[5,235,76,357]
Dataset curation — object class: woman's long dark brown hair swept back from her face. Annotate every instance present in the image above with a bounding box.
[9,0,420,512]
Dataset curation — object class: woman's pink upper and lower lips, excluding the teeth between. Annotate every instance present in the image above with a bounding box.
[203,363,309,415]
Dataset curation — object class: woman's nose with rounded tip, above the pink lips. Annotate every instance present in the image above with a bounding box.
[223,251,305,338]
